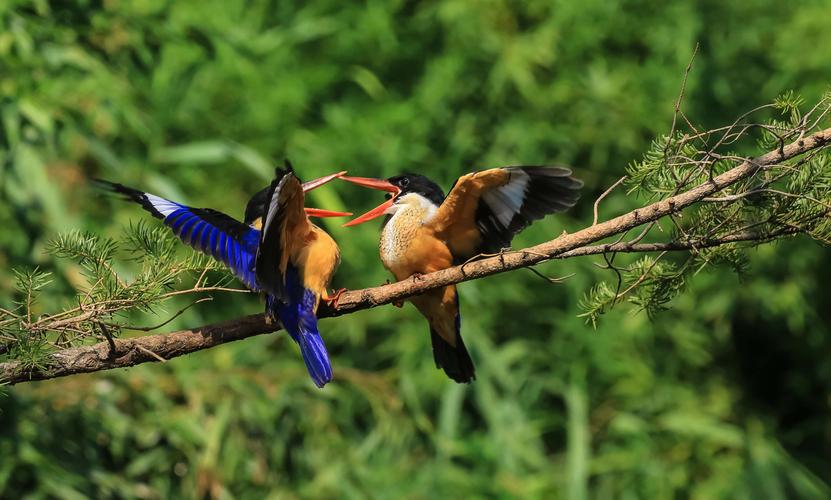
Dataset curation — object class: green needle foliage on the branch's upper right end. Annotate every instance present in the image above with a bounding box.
[596,91,831,327]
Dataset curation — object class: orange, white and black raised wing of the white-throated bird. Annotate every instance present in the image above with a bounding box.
[432,166,583,260]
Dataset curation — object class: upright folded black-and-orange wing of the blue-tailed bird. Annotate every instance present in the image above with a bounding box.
[254,165,312,301]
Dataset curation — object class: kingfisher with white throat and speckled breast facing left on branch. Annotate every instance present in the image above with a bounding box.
[340,166,583,383]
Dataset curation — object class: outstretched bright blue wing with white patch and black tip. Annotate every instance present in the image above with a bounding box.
[96,179,260,290]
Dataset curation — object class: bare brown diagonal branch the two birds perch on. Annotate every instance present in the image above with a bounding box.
[0,128,831,384]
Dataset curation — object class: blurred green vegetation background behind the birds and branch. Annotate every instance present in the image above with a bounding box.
[0,0,831,499]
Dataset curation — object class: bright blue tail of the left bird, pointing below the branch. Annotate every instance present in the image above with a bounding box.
[266,266,332,387]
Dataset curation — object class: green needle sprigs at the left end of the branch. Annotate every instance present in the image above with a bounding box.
[0,221,240,367]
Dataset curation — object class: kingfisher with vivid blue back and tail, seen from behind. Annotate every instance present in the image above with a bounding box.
[94,161,352,388]
